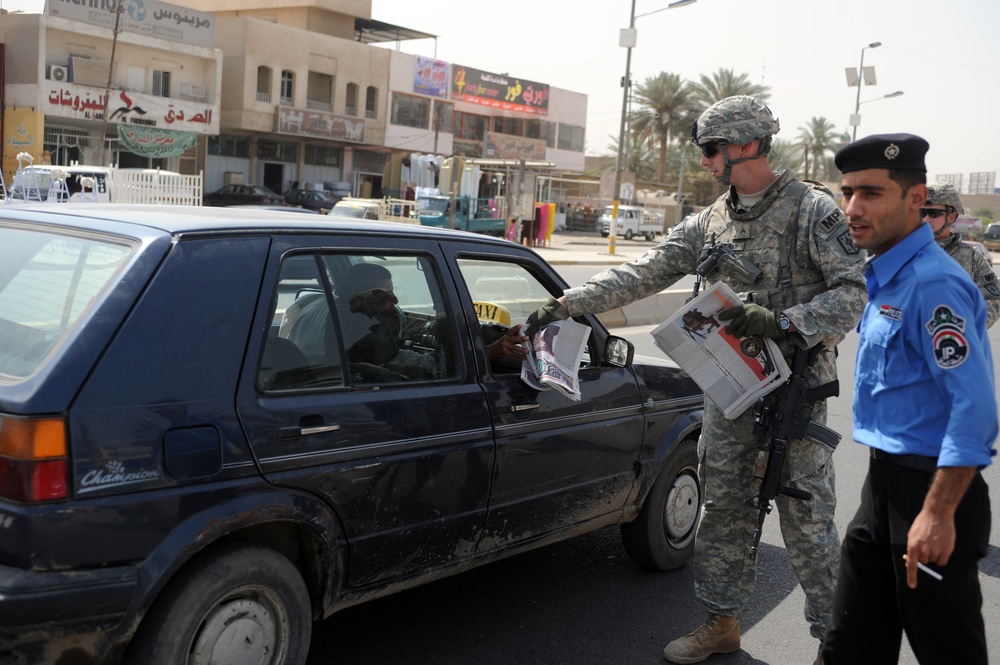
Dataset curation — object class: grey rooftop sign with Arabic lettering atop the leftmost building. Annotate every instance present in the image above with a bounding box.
[45,0,215,48]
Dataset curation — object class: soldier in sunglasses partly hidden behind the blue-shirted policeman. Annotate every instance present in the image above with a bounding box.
[920,182,1000,327]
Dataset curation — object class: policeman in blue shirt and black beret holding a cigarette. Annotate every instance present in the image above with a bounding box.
[823,134,998,665]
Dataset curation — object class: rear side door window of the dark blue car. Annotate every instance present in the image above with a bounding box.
[258,253,458,392]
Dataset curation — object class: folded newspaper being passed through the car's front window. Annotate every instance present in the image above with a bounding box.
[521,319,590,400]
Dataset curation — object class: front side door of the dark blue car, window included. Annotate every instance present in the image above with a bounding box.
[447,248,643,548]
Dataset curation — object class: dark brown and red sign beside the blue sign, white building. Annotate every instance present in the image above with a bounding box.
[451,65,549,115]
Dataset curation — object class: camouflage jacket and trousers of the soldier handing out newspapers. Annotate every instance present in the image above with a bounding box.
[565,171,867,638]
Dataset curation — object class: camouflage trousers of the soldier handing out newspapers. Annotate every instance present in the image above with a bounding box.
[694,399,840,639]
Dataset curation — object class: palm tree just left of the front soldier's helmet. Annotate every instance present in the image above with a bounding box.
[629,72,690,182]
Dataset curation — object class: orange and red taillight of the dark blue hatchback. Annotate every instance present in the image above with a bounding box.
[0,416,68,503]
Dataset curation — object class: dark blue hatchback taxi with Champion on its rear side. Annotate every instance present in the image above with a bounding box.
[0,205,702,665]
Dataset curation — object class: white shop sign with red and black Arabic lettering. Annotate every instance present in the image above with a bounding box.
[40,83,219,134]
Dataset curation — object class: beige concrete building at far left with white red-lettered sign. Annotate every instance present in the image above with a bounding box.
[0,0,222,181]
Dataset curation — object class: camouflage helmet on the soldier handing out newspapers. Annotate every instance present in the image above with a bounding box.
[691,95,779,149]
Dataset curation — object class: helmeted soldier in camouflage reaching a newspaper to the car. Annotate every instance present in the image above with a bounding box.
[527,95,866,663]
